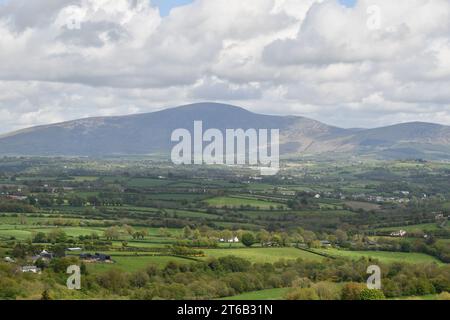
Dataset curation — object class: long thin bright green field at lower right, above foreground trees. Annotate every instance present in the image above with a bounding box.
[315,249,443,264]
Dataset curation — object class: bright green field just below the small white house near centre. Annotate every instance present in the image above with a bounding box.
[203,248,324,263]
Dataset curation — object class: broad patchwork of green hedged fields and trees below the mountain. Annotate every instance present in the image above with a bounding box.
[0,158,450,300]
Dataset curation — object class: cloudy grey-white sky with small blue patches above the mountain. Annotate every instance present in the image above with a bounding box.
[0,0,450,133]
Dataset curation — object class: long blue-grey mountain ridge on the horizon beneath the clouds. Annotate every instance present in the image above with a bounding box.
[0,103,450,159]
